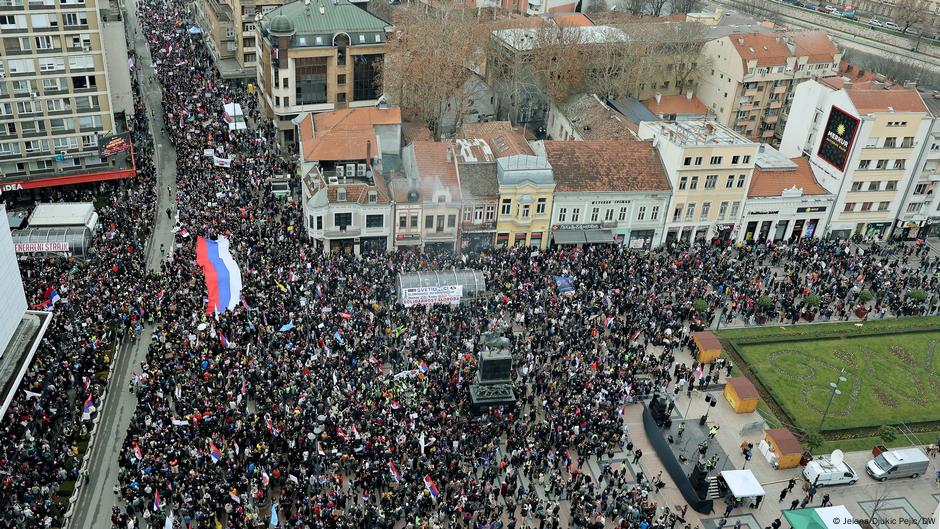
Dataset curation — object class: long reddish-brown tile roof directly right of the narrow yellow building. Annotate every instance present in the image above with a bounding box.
[544,140,672,193]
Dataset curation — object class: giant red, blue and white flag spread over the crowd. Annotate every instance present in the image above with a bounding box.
[196,237,242,314]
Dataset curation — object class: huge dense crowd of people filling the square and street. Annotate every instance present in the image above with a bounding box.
[0,0,940,529]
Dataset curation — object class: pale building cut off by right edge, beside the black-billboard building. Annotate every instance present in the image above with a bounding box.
[894,92,940,239]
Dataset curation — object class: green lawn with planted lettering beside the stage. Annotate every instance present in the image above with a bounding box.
[720,318,940,431]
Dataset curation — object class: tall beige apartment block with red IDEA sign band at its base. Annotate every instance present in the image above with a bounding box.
[0,0,135,191]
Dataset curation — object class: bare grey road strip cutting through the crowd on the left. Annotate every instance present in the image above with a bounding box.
[67,0,176,529]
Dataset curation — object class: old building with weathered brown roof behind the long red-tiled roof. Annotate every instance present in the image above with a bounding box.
[547,94,636,141]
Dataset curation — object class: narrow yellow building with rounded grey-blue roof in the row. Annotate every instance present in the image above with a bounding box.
[496,154,555,250]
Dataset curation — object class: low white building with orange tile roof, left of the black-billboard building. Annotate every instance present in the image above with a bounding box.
[737,145,835,243]
